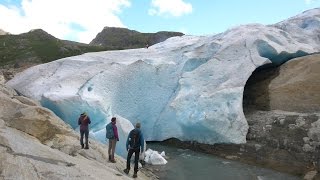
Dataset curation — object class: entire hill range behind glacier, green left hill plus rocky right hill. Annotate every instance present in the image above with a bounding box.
[0,27,183,67]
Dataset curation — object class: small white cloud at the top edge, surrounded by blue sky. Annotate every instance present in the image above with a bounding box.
[148,0,192,17]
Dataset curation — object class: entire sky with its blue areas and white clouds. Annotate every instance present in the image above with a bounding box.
[0,0,320,43]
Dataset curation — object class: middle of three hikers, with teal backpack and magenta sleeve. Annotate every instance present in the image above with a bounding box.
[106,117,119,163]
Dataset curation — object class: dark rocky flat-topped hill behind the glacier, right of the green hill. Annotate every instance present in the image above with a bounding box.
[90,27,184,49]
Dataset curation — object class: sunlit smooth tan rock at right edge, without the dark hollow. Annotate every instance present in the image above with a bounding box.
[269,54,320,112]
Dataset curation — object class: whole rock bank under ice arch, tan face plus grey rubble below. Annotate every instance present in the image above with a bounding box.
[235,54,320,175]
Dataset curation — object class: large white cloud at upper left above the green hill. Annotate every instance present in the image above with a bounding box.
[0,0,130,43]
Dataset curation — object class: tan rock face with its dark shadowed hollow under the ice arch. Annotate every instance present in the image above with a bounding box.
[244,54,320,113]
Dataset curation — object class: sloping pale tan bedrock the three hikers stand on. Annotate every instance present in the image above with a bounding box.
[0,84,154,180]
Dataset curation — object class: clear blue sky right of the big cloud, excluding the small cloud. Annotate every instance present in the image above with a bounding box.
[120,0,320,35]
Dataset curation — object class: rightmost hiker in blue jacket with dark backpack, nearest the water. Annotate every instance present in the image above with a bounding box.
[123,123,144,178]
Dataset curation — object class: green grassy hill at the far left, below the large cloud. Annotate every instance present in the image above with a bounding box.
[0,30,108,66]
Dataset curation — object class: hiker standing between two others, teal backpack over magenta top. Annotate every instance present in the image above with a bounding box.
[107,117,119,163]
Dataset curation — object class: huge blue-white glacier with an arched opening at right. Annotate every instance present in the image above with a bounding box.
[7,8,320,146]
